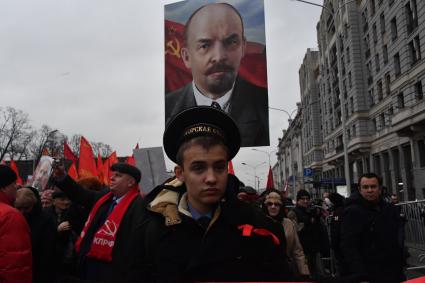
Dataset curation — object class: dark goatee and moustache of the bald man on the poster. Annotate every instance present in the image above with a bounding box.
[206,64,236,95]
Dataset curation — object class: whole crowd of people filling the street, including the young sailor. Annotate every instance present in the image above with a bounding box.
[0,106,404,283]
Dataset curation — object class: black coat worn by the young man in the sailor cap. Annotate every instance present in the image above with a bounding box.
[135,176,291,282]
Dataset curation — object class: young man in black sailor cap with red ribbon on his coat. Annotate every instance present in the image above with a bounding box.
[139,106,289,282]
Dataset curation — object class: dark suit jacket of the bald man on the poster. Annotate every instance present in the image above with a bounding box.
[165,77,270,146]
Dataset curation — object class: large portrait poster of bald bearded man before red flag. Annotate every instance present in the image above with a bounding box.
[164,0,270,147]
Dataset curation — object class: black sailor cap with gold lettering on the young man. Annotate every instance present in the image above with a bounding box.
[163,106,241,163]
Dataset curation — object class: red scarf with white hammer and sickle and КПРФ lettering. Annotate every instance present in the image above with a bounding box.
[75,188,139,262]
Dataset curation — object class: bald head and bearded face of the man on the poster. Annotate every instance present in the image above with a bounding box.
[182,4,245,98]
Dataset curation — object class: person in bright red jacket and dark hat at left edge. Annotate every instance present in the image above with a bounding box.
[0,165,32,283]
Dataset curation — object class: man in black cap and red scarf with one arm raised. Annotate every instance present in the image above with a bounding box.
[53,163,144,282]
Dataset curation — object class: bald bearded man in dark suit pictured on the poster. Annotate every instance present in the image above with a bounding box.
[165,3,270,146]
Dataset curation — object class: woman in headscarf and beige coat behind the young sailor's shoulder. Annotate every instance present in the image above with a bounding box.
[262,189,310,277]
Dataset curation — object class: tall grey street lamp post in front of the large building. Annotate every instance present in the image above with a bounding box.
[291,0,357,194]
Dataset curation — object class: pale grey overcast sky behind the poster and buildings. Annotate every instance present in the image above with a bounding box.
[0,0,322,191]
